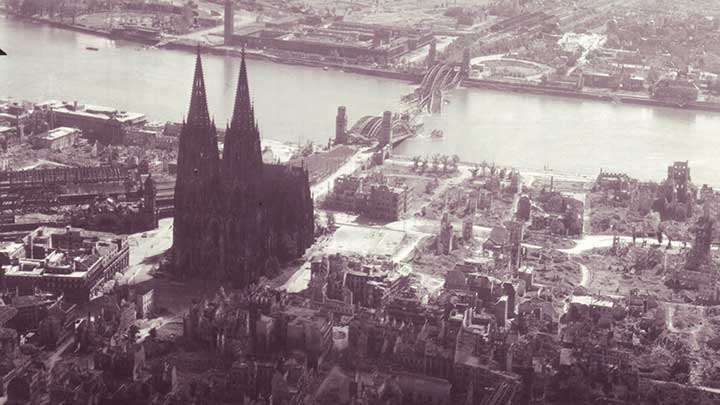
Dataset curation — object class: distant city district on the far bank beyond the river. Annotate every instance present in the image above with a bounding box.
[5,0,720,111]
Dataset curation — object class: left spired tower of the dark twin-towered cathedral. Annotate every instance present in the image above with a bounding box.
[173,47,222,276]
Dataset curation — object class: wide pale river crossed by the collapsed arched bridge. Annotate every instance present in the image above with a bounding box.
[0,17,720,185]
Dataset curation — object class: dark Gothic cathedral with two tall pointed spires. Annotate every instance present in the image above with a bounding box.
[171,49,314,288]
